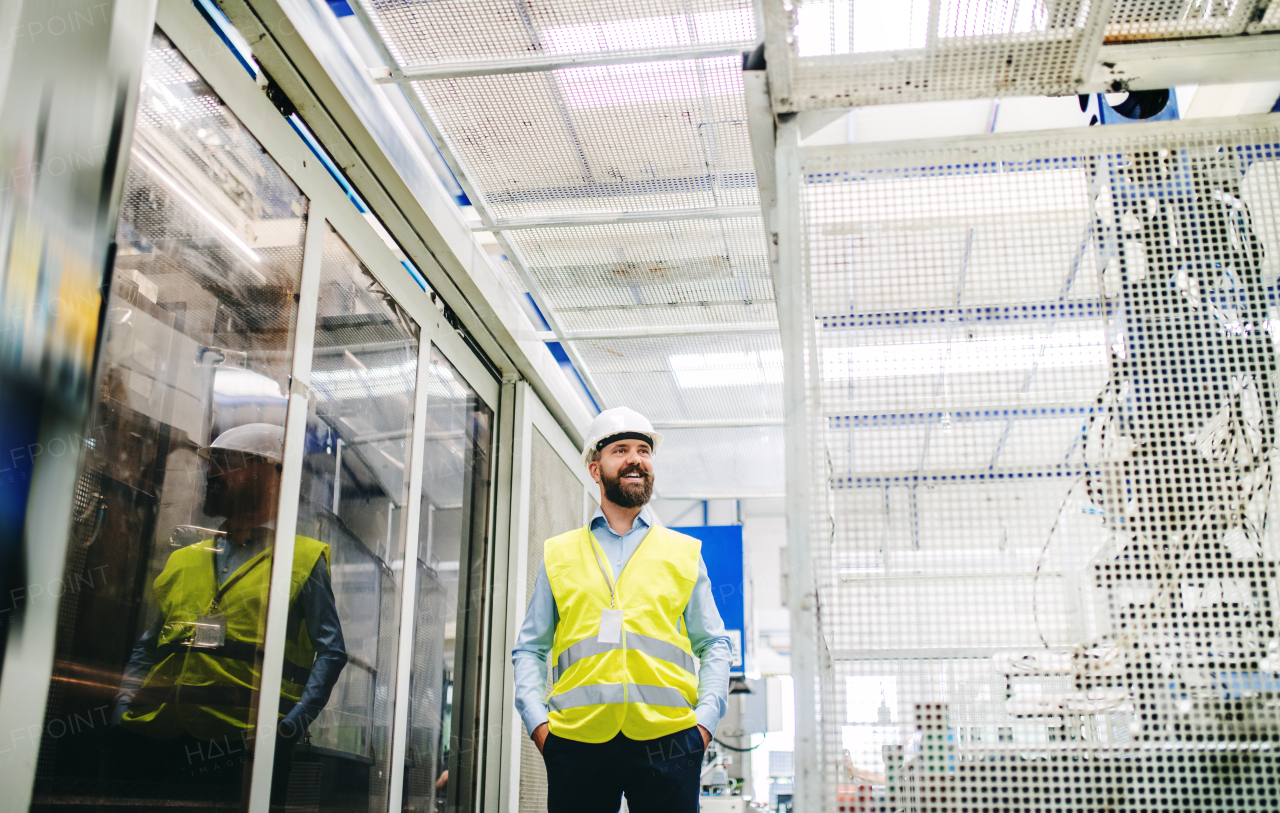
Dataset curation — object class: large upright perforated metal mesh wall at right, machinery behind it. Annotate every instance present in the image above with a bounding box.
[788,117,1280,810]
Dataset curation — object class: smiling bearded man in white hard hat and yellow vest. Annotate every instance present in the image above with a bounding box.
[512,407,730,813]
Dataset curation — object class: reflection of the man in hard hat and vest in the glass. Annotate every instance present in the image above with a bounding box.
[115,424,347,795]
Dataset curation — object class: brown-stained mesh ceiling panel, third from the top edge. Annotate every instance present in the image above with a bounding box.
[508,218,773,329]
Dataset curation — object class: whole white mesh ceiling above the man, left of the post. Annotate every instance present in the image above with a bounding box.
[353,0,783,498]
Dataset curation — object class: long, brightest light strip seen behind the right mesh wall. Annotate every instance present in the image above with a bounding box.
[822,330,1106,382]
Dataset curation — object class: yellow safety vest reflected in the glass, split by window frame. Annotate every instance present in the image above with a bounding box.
[120,536,329,739]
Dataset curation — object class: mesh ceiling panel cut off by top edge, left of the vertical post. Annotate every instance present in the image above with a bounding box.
[362,0,755,69]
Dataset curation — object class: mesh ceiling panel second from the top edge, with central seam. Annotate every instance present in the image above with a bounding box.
[412,56,756,218]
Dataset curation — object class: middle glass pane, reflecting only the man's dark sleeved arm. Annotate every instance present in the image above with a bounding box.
[274,221,419,810]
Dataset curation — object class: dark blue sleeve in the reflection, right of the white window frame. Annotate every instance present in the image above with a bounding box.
[280,557,347,736]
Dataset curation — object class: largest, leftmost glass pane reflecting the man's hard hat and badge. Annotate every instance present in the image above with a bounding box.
[29,35,307,810]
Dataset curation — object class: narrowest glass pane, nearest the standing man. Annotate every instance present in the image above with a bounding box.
[403,355,493,813]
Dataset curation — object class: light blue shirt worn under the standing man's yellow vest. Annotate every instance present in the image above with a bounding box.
[511,507,731,734]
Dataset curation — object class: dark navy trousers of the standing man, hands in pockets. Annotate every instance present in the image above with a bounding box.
[543,726,704,813]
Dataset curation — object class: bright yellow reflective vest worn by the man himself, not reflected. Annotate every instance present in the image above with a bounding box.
[543,526,701,743]
